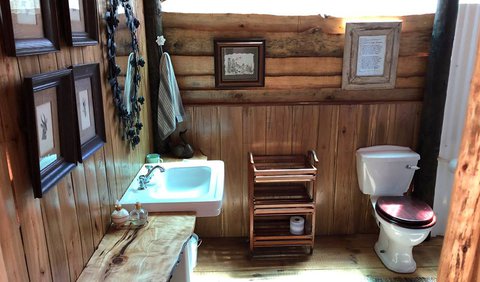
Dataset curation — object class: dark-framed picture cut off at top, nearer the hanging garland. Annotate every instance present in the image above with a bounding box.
[61,0,98,46]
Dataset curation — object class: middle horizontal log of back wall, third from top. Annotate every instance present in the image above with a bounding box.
[172,56,428,77]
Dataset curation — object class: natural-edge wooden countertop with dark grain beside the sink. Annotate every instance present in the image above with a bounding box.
[78,214,195,282]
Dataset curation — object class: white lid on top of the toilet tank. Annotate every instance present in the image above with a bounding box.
[357,145,420,160]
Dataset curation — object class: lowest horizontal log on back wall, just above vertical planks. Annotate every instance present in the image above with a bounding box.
[181,88,423,105]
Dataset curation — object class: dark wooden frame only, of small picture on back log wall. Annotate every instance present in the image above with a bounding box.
[214,39,265,88]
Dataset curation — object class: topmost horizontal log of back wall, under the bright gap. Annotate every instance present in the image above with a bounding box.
[163,12,434,34]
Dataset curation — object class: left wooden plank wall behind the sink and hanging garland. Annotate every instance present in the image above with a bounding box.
[0,1,151,281]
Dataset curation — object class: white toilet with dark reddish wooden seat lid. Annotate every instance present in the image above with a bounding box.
[357,146,436,273]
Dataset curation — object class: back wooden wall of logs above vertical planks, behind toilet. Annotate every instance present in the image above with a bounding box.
[163,13,433,236]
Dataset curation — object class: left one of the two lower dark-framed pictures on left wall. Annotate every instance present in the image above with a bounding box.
[24,70,78,198]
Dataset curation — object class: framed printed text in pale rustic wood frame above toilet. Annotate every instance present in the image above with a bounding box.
[342,21,402,90]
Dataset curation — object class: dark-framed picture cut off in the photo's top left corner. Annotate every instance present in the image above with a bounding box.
[0,0,60,56]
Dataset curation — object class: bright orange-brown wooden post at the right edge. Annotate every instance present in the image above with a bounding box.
[438,34,480,281]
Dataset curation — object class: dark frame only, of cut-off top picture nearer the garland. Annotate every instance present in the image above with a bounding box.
[61,0,98,46]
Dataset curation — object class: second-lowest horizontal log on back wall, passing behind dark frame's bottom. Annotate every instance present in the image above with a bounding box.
[177,75,425,90]
